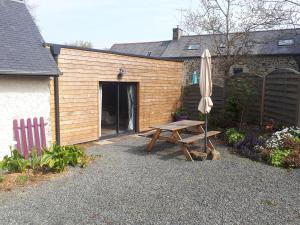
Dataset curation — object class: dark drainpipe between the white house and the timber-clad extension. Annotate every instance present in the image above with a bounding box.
[50,45,60,145]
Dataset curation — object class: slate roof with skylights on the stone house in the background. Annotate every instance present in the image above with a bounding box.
[111,29,300,58]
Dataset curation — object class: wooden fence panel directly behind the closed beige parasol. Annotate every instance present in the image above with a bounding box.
[183,84,224,119]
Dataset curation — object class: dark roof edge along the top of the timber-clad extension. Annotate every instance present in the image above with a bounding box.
[45,43,183,62]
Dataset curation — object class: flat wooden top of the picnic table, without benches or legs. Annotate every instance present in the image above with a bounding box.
[151,120,205,131]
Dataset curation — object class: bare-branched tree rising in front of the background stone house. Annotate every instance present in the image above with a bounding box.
[185,0,299,78]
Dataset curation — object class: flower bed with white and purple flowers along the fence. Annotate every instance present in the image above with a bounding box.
[225,127,300,168]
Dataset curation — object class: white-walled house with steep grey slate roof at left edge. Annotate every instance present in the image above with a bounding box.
[0,0,60,159]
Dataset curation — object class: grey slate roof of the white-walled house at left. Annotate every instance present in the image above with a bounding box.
[0,0,60,76]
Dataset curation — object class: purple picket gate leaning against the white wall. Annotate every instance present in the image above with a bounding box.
[13,117,47,159]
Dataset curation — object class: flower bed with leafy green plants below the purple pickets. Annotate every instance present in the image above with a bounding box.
[0,145,96,191]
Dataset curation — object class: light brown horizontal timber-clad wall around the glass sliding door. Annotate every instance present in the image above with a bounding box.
[51,48,183,144]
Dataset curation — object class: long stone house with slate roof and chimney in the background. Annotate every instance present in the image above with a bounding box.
[111,28,300,86]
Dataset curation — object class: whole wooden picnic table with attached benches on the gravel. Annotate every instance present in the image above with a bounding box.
[141,120,219,161]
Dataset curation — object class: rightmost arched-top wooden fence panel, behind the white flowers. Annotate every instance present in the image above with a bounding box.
[263,69,300,126]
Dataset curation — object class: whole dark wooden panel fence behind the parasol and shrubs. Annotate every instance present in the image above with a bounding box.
[183,69,300,126]
